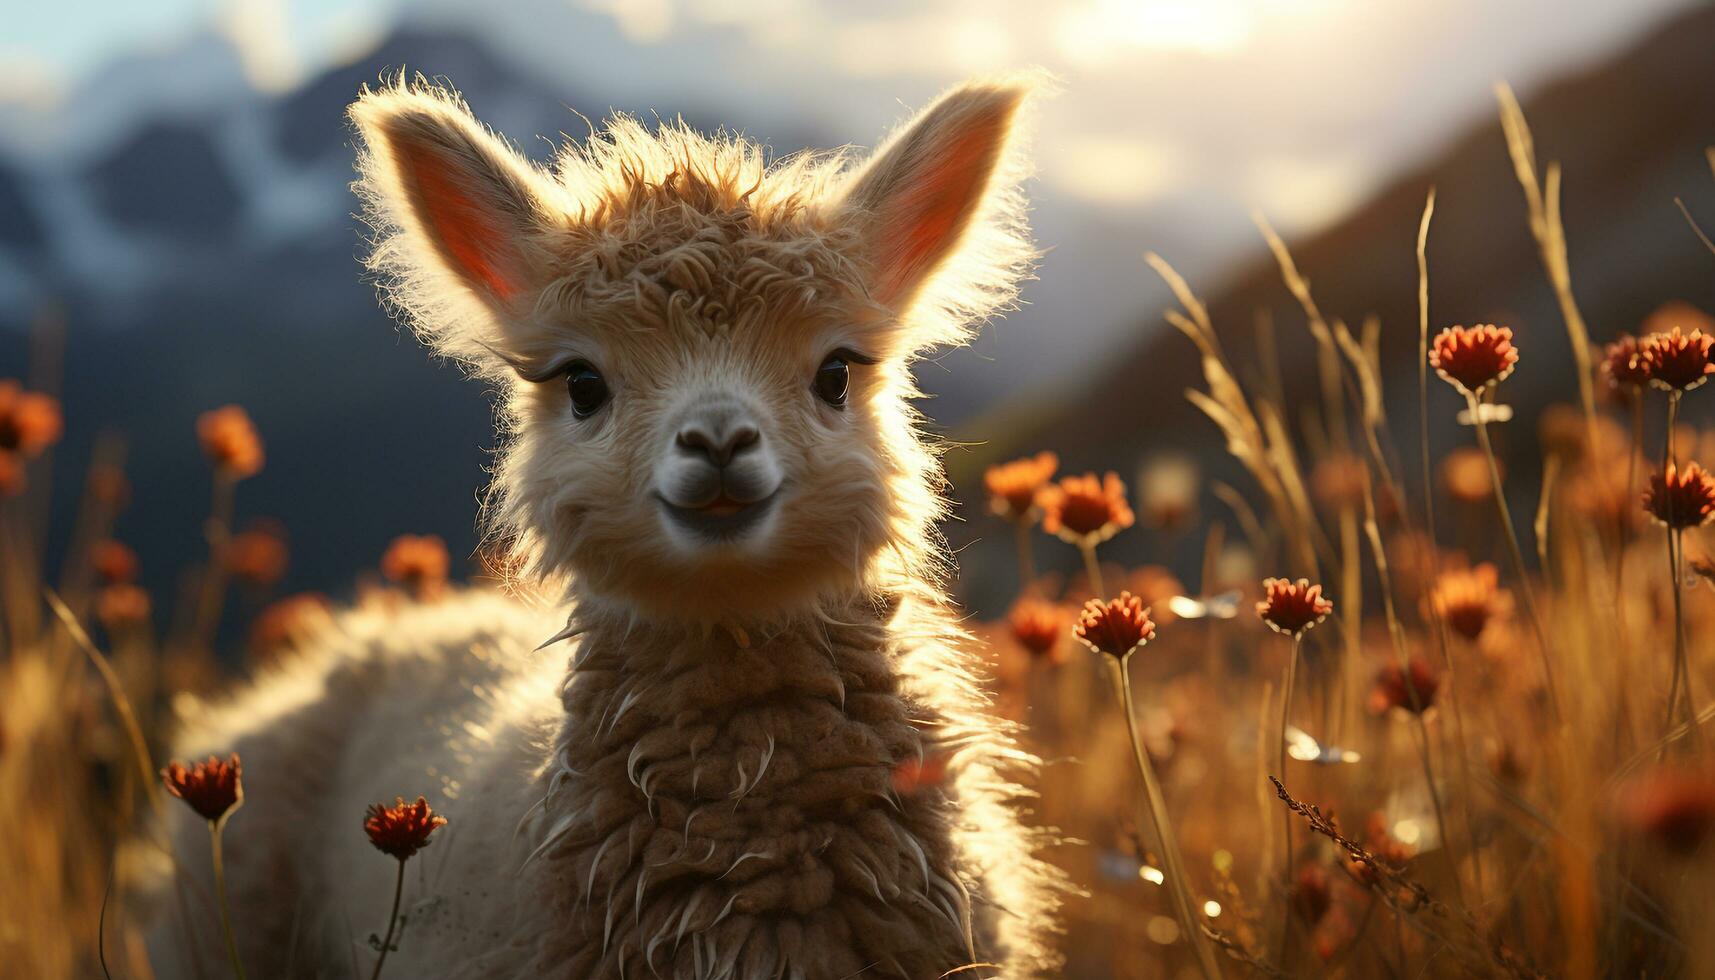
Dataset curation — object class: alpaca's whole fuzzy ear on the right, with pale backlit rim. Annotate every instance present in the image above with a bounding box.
[842,81,1032,343]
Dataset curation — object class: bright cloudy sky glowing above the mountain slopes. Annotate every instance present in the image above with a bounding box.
[0,0,1693,394]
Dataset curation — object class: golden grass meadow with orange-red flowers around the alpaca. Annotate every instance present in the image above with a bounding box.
[0,88,1715,978]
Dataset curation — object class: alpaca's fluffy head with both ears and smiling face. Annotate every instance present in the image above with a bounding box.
[352,81,1031,620]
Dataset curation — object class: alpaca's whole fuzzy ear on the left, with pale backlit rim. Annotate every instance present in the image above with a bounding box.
[350,82,564,360]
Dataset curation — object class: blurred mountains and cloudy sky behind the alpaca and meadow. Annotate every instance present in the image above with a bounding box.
[0,0,1715,628]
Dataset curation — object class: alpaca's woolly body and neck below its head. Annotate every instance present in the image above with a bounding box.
[156,592,1053,978]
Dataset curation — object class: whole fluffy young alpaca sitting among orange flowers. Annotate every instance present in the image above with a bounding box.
[153,72,1065,980]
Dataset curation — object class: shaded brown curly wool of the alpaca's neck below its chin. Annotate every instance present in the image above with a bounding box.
[544,599,994,977]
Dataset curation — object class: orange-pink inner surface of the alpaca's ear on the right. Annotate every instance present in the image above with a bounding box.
[880,115,1005,300]
